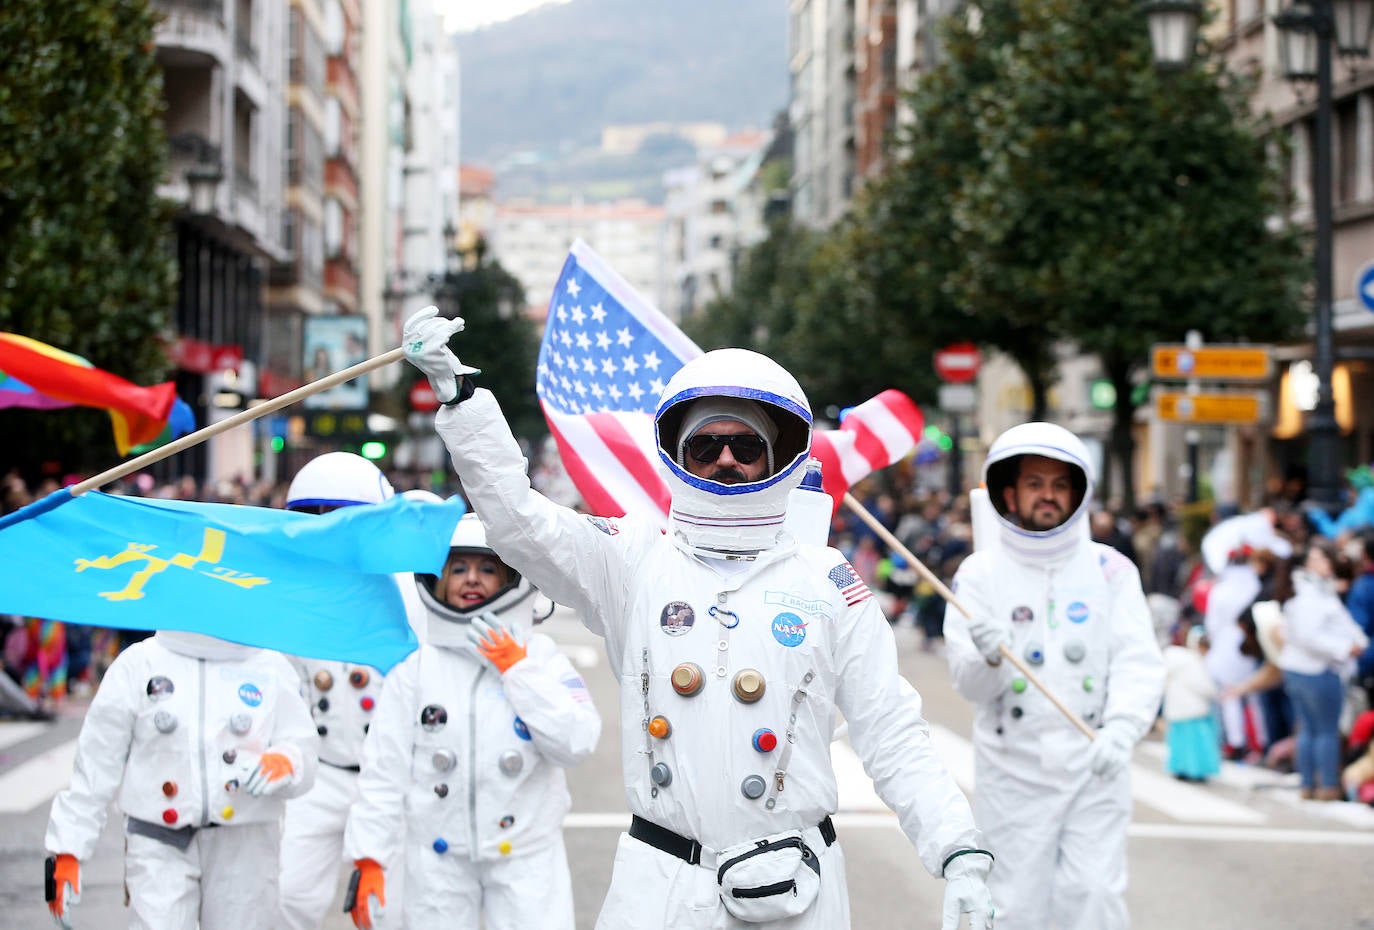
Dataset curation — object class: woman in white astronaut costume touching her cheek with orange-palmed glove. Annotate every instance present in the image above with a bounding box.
[345,514,600,930]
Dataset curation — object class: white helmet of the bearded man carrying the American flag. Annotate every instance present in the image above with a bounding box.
[982,422,1095,552]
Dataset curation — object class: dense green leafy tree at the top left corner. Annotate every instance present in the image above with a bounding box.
[0,0,176,474]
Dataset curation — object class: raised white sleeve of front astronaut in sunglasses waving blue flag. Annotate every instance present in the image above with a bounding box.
[434,389,643,648]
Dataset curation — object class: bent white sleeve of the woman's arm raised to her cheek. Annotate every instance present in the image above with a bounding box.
[502,633,600,768]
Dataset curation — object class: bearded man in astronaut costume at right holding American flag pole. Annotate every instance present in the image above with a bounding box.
[945,423,1164,930]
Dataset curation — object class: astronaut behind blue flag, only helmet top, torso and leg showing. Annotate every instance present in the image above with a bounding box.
[273,452,411,930]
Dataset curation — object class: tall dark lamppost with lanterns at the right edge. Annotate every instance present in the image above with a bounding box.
[1274,0,1374,511]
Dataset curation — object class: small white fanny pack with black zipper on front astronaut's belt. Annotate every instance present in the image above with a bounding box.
[716,832,820,923]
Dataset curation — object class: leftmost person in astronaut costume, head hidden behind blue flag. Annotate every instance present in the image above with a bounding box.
[44,631,317,930]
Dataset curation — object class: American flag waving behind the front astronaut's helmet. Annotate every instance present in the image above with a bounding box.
[534,239,925,523]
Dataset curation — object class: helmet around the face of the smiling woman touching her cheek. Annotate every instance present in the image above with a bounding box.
[415,514,534,631]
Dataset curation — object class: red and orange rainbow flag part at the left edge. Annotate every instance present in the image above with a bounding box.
[0,332,176,455]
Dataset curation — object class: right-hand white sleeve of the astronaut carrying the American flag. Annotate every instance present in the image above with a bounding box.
[1101,547,1165,739]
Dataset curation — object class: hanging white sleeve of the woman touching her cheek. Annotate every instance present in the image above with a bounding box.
[344,646,425,868]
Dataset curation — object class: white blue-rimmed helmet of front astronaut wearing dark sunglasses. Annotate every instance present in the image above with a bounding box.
[654,349,812,555]
